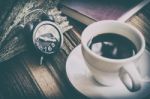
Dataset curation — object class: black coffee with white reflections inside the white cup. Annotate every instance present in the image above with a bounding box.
[88,33,137,59]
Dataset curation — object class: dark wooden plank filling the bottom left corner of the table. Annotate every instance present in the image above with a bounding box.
[0,55,45,99]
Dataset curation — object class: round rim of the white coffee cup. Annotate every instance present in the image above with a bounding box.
[81,20,145,63]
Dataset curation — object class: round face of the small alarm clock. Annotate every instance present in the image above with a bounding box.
[33,21,62,54]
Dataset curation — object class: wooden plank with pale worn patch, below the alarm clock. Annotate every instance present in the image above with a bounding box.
[20,52,64,99]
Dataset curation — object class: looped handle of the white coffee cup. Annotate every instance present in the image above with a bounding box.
[119,63,141,92]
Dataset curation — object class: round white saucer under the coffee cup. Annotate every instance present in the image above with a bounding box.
[66,45,150,99]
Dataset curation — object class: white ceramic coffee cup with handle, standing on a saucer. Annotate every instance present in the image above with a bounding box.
[81,20,145,92]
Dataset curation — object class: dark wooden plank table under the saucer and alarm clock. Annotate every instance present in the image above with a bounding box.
[0,0,150,99]
